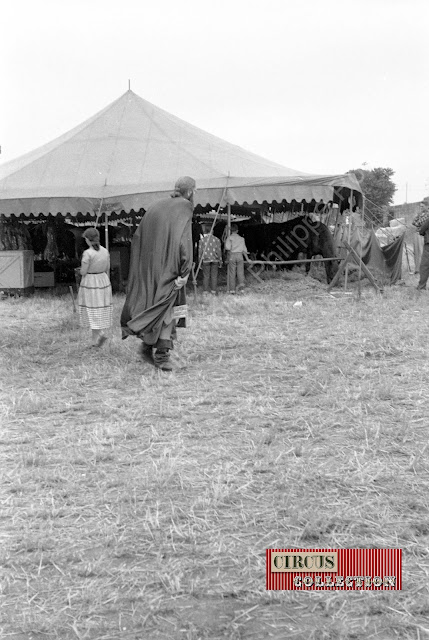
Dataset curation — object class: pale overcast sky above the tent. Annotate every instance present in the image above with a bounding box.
[0,0,429,204]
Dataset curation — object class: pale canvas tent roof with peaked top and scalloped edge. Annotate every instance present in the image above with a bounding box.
[0,90,361,217]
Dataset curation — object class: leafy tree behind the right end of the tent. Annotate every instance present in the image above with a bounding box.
[353,167,396,225]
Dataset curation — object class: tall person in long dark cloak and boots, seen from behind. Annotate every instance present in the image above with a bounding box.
[121,176,196,371]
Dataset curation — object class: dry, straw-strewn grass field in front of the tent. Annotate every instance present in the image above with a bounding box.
[0,273,429,640]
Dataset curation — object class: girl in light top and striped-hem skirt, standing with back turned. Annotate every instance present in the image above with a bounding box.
[78,227,112,347]
